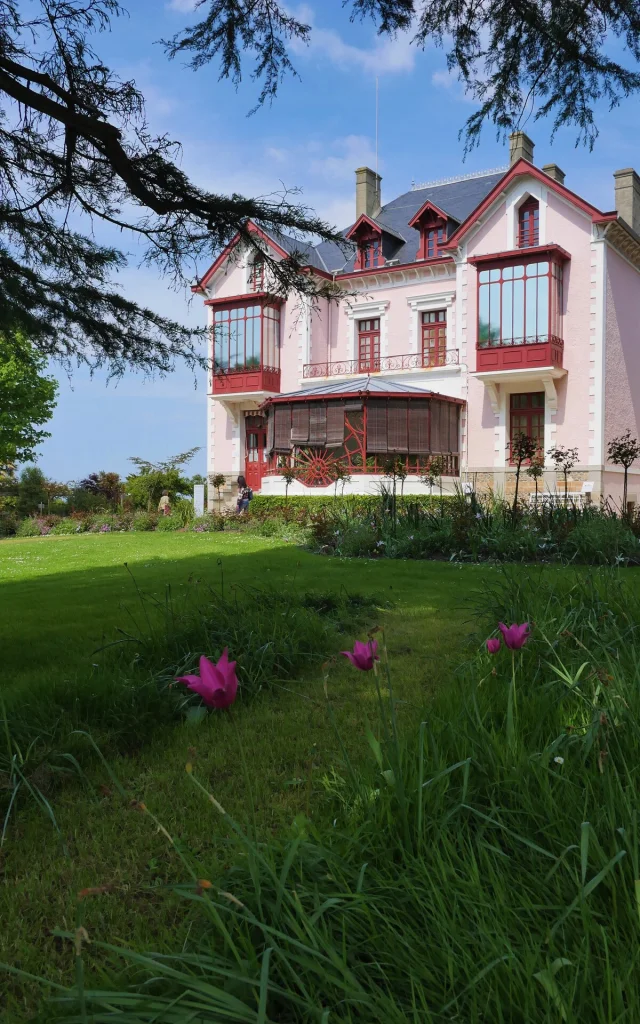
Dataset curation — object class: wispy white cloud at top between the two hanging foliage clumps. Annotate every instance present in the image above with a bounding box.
[288,0,416,75]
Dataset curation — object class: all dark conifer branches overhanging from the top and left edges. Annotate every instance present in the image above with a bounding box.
[0,0,640,374]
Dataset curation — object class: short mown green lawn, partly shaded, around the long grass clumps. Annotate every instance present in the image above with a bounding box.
[0,534,498,1024]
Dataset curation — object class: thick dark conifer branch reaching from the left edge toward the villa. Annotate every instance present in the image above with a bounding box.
[0,0,339,374]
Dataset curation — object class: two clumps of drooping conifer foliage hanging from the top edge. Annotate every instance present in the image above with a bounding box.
[175,0,640,146]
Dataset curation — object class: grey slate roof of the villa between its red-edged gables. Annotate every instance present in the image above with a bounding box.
[311,171,506,273]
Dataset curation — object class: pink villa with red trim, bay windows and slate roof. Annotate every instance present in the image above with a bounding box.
[194,132,640,502]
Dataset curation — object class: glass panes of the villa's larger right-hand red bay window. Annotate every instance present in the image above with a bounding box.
[478,261,562,348]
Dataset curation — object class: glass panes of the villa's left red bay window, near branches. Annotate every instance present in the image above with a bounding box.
[213,305,280,373]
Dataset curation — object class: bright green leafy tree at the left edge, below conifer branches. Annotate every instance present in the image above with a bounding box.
[0,331,57,469]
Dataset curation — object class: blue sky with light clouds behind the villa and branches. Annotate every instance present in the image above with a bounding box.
[33,0,640,481]
